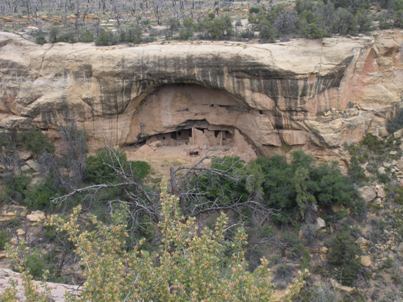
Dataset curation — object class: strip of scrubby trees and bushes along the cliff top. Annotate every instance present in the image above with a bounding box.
[0,0,403,45]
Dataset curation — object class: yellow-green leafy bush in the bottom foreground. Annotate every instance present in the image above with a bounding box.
[49,193,303,302]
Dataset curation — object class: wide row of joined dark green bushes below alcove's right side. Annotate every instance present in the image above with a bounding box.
[184,152,363,224]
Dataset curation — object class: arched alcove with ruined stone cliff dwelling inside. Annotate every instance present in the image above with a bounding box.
[126,84,262,166]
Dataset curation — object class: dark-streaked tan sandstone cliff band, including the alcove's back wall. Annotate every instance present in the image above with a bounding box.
[0,31,403,153]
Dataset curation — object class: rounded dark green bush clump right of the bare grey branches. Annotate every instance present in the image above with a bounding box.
[257,152,359,223]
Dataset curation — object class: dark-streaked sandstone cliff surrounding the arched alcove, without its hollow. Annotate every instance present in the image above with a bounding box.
[0,32,402,157]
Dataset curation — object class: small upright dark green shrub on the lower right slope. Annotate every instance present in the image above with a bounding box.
[328,229,362,286]
